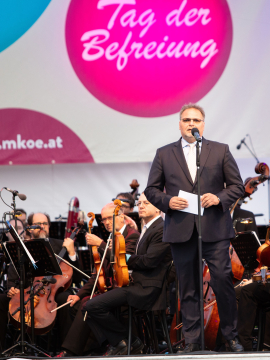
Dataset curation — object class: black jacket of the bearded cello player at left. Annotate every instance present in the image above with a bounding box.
[7,238,82,290]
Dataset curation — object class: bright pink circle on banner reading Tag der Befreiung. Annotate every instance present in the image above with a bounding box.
[66,0,233,117]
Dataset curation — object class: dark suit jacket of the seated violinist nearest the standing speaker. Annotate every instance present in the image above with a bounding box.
[127,218,172,310]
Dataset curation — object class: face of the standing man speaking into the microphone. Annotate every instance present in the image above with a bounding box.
[179,108,204,143]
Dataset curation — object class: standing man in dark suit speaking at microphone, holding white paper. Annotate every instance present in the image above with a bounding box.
[145,104,244,353]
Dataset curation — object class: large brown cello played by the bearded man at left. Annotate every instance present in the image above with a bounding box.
[9,228,80,335]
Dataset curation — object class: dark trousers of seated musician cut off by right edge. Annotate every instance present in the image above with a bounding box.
[237,282,270,351]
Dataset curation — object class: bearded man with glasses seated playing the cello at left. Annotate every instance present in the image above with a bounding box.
[1,213,82,343]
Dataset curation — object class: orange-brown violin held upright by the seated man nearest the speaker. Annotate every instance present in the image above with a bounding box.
[110,199,129,287]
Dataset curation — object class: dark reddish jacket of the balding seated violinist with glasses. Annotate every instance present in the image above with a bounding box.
[77,225,140,299]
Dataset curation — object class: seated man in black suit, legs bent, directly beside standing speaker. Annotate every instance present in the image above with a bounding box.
[58,194,171,356]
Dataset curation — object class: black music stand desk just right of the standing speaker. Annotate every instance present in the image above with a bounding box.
[231,231,261,272]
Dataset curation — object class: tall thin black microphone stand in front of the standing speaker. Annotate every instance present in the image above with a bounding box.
[196,138,205,350]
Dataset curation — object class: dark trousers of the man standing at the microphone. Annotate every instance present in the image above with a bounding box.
[171,227,237,344]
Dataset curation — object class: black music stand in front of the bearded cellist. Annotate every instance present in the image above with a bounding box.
[2,238,62,356]
